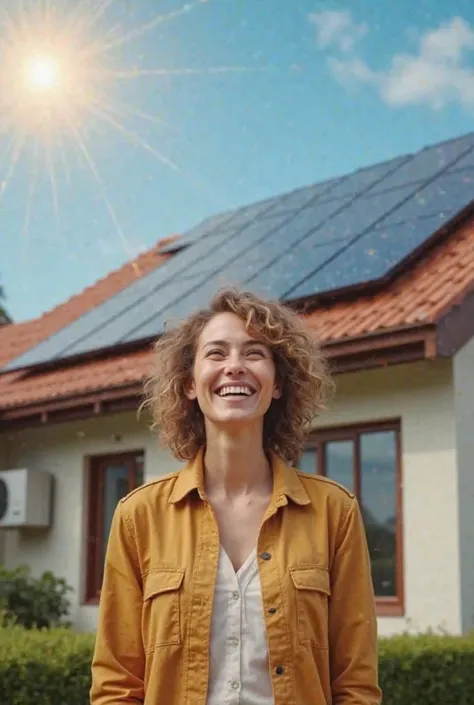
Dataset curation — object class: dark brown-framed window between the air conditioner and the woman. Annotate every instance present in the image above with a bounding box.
[86,452,143,602]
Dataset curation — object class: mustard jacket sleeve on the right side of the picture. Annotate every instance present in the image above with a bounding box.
[329,498,382,705]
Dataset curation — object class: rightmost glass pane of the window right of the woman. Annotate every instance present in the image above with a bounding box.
[360,431,397,597]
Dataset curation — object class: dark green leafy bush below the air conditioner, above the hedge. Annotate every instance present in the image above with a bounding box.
[0,566,72,629]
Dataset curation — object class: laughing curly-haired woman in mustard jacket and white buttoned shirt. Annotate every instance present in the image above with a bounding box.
[91,289,381,705]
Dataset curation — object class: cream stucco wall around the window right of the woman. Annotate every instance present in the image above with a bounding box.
[319,361,461,635]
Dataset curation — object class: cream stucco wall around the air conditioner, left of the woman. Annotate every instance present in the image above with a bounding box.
[0,413,179,630]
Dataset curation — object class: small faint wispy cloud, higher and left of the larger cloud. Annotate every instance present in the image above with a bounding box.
[309,10,368,52]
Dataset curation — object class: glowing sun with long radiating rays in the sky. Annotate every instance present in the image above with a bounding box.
[0,0,261,257]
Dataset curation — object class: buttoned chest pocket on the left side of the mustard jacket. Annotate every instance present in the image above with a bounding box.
[142,569,184,653]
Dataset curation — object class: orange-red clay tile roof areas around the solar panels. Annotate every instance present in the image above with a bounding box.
[0,222,474,410]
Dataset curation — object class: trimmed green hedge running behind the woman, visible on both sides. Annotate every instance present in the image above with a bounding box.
[0,627,474,705]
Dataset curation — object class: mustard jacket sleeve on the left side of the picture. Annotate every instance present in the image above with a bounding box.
[90,503,145,705]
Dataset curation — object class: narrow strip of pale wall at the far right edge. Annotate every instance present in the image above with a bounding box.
[453,340,474,631]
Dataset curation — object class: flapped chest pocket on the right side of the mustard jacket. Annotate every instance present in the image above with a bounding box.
[290,566,331,649]
